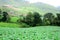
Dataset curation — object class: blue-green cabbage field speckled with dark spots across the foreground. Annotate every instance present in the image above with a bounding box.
[0,26,60,40]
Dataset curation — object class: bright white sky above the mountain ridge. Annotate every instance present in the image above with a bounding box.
[28,0,60,7]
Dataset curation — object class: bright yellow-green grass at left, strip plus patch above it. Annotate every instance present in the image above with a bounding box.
[0,17,20,28]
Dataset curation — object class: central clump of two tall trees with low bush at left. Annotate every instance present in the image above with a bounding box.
[19,12,42,26]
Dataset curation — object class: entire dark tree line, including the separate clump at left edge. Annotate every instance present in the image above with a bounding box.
[0,10,60,27]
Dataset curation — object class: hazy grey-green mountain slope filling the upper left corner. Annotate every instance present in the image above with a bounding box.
[0,0,29,7]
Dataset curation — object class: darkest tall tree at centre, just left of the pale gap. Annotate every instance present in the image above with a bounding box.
[33,12,42,26]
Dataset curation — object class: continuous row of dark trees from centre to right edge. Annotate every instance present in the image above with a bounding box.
[18,12,60,27]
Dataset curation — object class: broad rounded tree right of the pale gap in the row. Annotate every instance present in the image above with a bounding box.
[43,13,55,25]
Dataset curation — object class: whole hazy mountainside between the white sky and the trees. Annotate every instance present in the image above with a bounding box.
[0,0,60,15]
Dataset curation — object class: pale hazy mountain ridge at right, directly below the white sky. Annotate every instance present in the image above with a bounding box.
[31,2,59,13]
